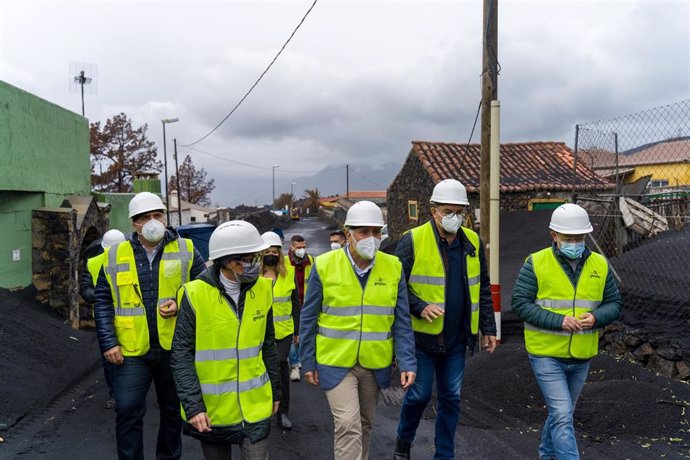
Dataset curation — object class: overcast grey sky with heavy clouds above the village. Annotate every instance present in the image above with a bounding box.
[0,0,690,206]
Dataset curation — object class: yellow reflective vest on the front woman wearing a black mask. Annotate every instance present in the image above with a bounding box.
[178,278,273,427]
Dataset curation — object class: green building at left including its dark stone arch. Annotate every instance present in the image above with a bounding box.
[0,81,109,326]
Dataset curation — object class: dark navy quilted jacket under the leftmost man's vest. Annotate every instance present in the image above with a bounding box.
[94,228,206,352]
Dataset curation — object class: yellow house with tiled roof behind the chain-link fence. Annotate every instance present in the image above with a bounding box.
[578,137,690,192]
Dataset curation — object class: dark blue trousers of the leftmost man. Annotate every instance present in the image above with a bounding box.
[114,348,182,460]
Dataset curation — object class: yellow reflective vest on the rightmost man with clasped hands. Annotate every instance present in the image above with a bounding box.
[525,247,608,359]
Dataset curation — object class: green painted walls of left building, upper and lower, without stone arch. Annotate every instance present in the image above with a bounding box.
[0,81,91,288]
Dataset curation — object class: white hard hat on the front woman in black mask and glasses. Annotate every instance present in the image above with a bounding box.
[208,220,269,260]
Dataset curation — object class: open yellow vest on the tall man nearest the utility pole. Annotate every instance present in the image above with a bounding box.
[407,221,481,335]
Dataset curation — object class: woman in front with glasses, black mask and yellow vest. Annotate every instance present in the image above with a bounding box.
[170,221,280,460]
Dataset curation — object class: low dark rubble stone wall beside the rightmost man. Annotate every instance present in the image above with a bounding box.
[600,322,690,381]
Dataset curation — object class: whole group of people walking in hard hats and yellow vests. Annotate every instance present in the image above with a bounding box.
[86,179,620,460]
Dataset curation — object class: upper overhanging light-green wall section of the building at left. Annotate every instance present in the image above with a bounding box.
[0,81,91,195]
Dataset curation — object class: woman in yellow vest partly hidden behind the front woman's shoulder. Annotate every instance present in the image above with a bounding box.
[261,232,299,430]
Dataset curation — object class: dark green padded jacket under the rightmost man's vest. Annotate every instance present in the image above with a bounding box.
[511,243,621,331]
